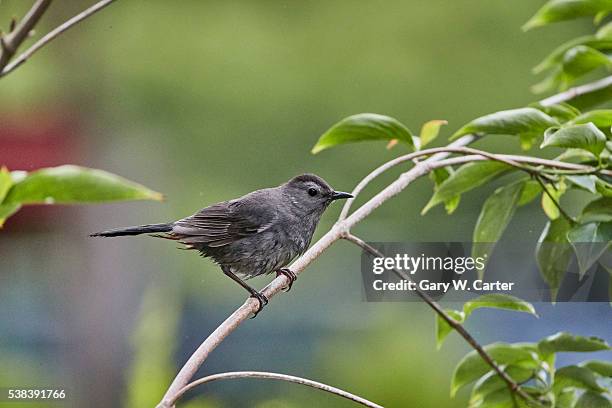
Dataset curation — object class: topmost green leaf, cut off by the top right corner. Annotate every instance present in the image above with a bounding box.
[523,0,612,31]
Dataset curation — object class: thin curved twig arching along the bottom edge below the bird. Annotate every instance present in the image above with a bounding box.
[163,371,383,408]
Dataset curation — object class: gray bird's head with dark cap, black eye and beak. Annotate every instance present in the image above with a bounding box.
[282,174,353,213]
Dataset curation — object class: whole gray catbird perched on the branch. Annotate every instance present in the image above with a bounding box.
[91,174,352,314]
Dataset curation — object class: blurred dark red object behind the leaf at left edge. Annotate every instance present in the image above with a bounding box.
[0,111,82,232]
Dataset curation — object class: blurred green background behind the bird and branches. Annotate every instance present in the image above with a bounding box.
[0,0,612,408]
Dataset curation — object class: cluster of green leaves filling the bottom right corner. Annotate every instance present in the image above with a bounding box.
[436,294,612,408]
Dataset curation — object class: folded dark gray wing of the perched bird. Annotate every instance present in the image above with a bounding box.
[172,200,278,247]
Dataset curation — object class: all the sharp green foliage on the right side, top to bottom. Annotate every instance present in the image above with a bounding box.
[313,0,612,408]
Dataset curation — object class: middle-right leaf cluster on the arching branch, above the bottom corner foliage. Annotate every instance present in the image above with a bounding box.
[313,104,612,300]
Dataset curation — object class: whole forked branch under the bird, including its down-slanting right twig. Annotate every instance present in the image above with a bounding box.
[158,76,612,408]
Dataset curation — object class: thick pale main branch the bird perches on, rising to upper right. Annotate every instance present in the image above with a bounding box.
[159,76,612,407]
